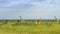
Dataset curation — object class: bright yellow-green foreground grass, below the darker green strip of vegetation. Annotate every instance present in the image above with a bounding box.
[0,24,60,34]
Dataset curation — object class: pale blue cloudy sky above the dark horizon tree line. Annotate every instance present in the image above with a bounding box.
[0,0,60,19]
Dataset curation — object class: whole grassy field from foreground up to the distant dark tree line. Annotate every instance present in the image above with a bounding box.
[0,21,60,34]
